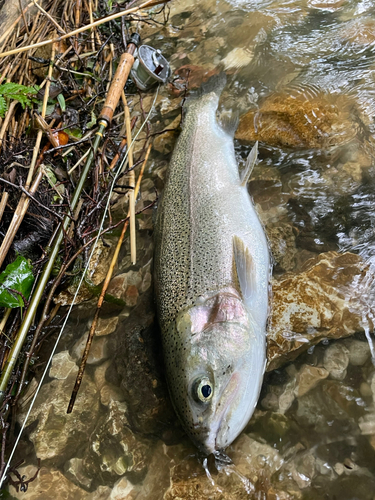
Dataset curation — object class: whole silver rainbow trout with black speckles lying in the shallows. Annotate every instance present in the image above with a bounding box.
[154,74,269,454]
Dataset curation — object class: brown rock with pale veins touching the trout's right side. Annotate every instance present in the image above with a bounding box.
[267,252,373,376]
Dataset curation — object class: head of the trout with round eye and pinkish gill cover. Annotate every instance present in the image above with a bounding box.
[167,292,265,454]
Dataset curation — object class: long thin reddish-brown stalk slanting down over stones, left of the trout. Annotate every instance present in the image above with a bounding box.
[67,142,152,413]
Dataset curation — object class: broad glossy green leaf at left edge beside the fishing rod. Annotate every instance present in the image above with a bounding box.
[0,255,34,309]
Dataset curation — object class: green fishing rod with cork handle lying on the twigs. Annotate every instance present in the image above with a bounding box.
[0,33,141,405]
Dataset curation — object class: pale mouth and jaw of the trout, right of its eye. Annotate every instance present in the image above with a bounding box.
[202,373,240,455]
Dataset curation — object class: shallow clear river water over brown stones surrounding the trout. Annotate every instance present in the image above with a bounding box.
[5,0,375,500]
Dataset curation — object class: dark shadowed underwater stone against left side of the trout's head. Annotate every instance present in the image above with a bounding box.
[106,291,179,436]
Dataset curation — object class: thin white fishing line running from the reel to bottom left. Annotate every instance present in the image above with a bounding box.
[0,85,160,488]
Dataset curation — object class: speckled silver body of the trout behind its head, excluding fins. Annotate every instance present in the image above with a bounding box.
[155,93,268,330]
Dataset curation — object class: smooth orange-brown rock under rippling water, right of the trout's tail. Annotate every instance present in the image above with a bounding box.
[235,87,356,148]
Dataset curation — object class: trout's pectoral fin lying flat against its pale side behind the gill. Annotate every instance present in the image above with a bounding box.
[233,236,256,306]
